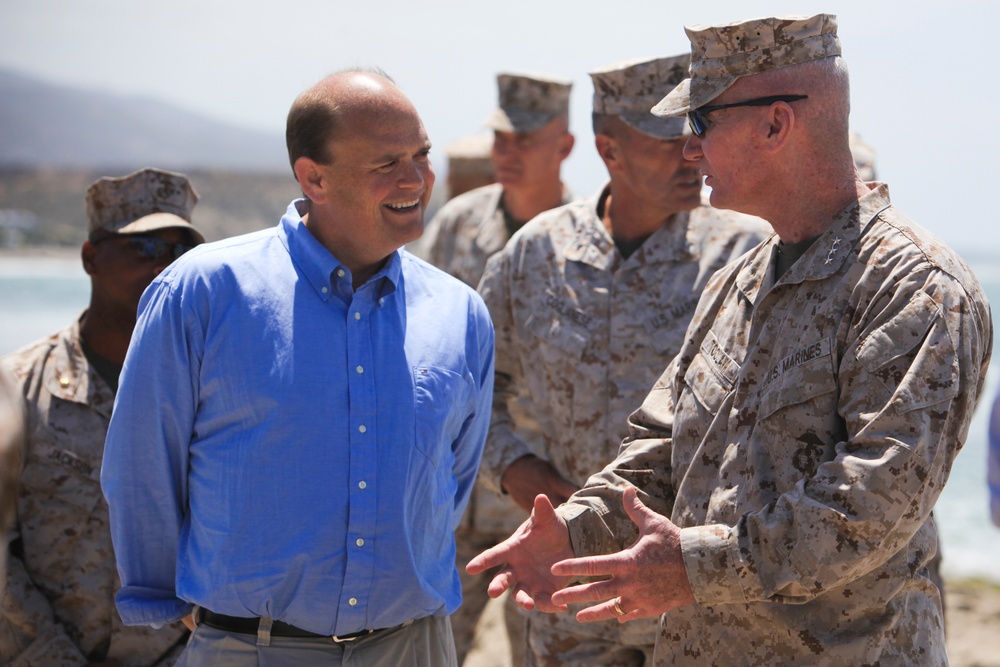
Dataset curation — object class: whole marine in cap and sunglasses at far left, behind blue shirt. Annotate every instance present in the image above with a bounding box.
[0,169,205,667]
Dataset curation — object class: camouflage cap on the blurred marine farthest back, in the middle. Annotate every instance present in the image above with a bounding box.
[484,73,573,132]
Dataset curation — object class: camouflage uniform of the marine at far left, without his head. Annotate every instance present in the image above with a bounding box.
[0,319,185,667]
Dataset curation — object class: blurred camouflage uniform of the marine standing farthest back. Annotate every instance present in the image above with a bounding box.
[417,183,571,662]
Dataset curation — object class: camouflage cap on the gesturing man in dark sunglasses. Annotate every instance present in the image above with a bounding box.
[653,14,840,116]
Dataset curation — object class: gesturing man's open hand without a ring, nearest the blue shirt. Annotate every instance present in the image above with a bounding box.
[465,494,573,612]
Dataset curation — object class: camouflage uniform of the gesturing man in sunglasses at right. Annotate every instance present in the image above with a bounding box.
[564,183,993,667]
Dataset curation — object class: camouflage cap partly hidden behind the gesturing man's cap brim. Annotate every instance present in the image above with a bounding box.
[590,53,691,139]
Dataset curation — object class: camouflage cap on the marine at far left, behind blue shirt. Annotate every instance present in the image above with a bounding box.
[87,168,205,243]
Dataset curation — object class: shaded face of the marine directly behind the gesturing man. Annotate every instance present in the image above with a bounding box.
[615,123,701,215]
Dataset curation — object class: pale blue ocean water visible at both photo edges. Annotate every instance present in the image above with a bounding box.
[0,253,1000,583]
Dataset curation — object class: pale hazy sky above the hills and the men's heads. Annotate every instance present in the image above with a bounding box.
[0,0,1000,255]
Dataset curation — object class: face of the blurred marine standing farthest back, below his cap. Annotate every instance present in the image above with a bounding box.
[492,117,573,188]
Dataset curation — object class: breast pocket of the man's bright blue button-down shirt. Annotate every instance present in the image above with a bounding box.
[413,366,476,468]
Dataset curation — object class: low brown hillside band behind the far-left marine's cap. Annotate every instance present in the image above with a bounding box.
[0,166,301,246]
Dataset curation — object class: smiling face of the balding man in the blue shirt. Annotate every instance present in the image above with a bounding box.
[320,106,434,256]
